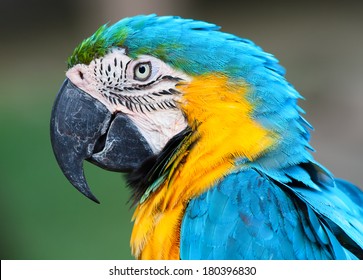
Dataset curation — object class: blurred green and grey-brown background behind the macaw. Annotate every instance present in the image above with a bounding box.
[0,0,363,259]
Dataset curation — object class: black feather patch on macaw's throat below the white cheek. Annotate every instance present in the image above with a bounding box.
[126,127,193,206]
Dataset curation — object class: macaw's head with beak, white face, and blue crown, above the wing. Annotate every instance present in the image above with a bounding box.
[51,15,309,201]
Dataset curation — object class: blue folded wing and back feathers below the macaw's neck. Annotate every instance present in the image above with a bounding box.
[180,164,363,259]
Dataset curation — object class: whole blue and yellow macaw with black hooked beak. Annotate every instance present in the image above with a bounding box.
[51,15,363,259]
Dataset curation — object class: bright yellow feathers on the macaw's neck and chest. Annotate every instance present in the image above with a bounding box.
[131,74,274,259]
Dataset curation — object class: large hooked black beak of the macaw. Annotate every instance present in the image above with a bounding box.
[50,79,153,203]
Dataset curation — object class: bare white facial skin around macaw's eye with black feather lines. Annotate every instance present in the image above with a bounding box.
[66,48,191,153]
